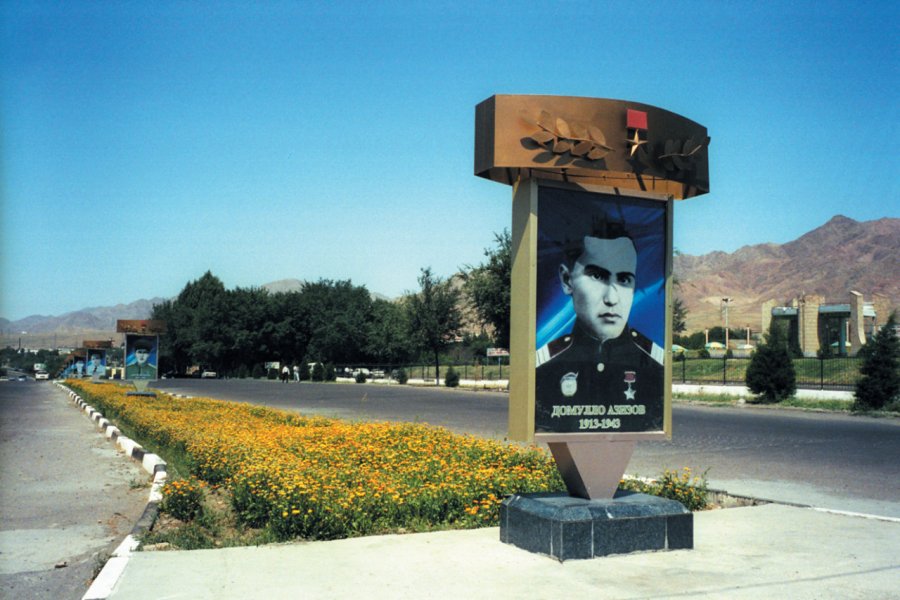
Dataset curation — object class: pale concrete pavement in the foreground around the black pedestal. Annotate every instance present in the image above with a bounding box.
[100,504,900,600]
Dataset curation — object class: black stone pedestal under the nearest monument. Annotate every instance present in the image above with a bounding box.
[500,491,694,561]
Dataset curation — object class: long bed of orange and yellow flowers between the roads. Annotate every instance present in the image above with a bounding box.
[69,381,565,539]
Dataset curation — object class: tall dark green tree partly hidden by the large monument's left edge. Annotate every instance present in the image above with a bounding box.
[463,230,512,348]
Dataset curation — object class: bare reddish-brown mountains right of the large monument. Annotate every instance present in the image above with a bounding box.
[673,215,900,332]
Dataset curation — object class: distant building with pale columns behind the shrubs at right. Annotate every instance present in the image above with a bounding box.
[761,291,878,356]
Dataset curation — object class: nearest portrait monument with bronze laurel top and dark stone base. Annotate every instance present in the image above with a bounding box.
[475,95,709,560]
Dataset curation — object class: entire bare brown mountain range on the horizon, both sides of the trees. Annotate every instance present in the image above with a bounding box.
[0,215,900,348]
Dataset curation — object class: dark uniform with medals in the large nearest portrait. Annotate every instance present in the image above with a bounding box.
[535,322,664,433]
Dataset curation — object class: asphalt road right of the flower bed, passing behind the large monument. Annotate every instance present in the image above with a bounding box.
[155,379,900,518]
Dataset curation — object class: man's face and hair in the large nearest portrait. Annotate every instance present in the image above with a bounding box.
[559,237,637,341]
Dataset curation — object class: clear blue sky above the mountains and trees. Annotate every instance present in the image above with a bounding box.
[0,0,900,319]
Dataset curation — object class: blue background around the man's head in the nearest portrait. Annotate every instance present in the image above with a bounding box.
[536,187,668,348]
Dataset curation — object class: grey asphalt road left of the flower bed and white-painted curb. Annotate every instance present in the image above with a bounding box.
[0,379,150,600]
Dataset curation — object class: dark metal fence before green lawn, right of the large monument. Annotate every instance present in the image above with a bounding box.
[672,357,862,390]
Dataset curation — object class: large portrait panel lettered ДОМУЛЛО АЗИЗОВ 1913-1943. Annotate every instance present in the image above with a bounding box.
[535,186,671,433]
